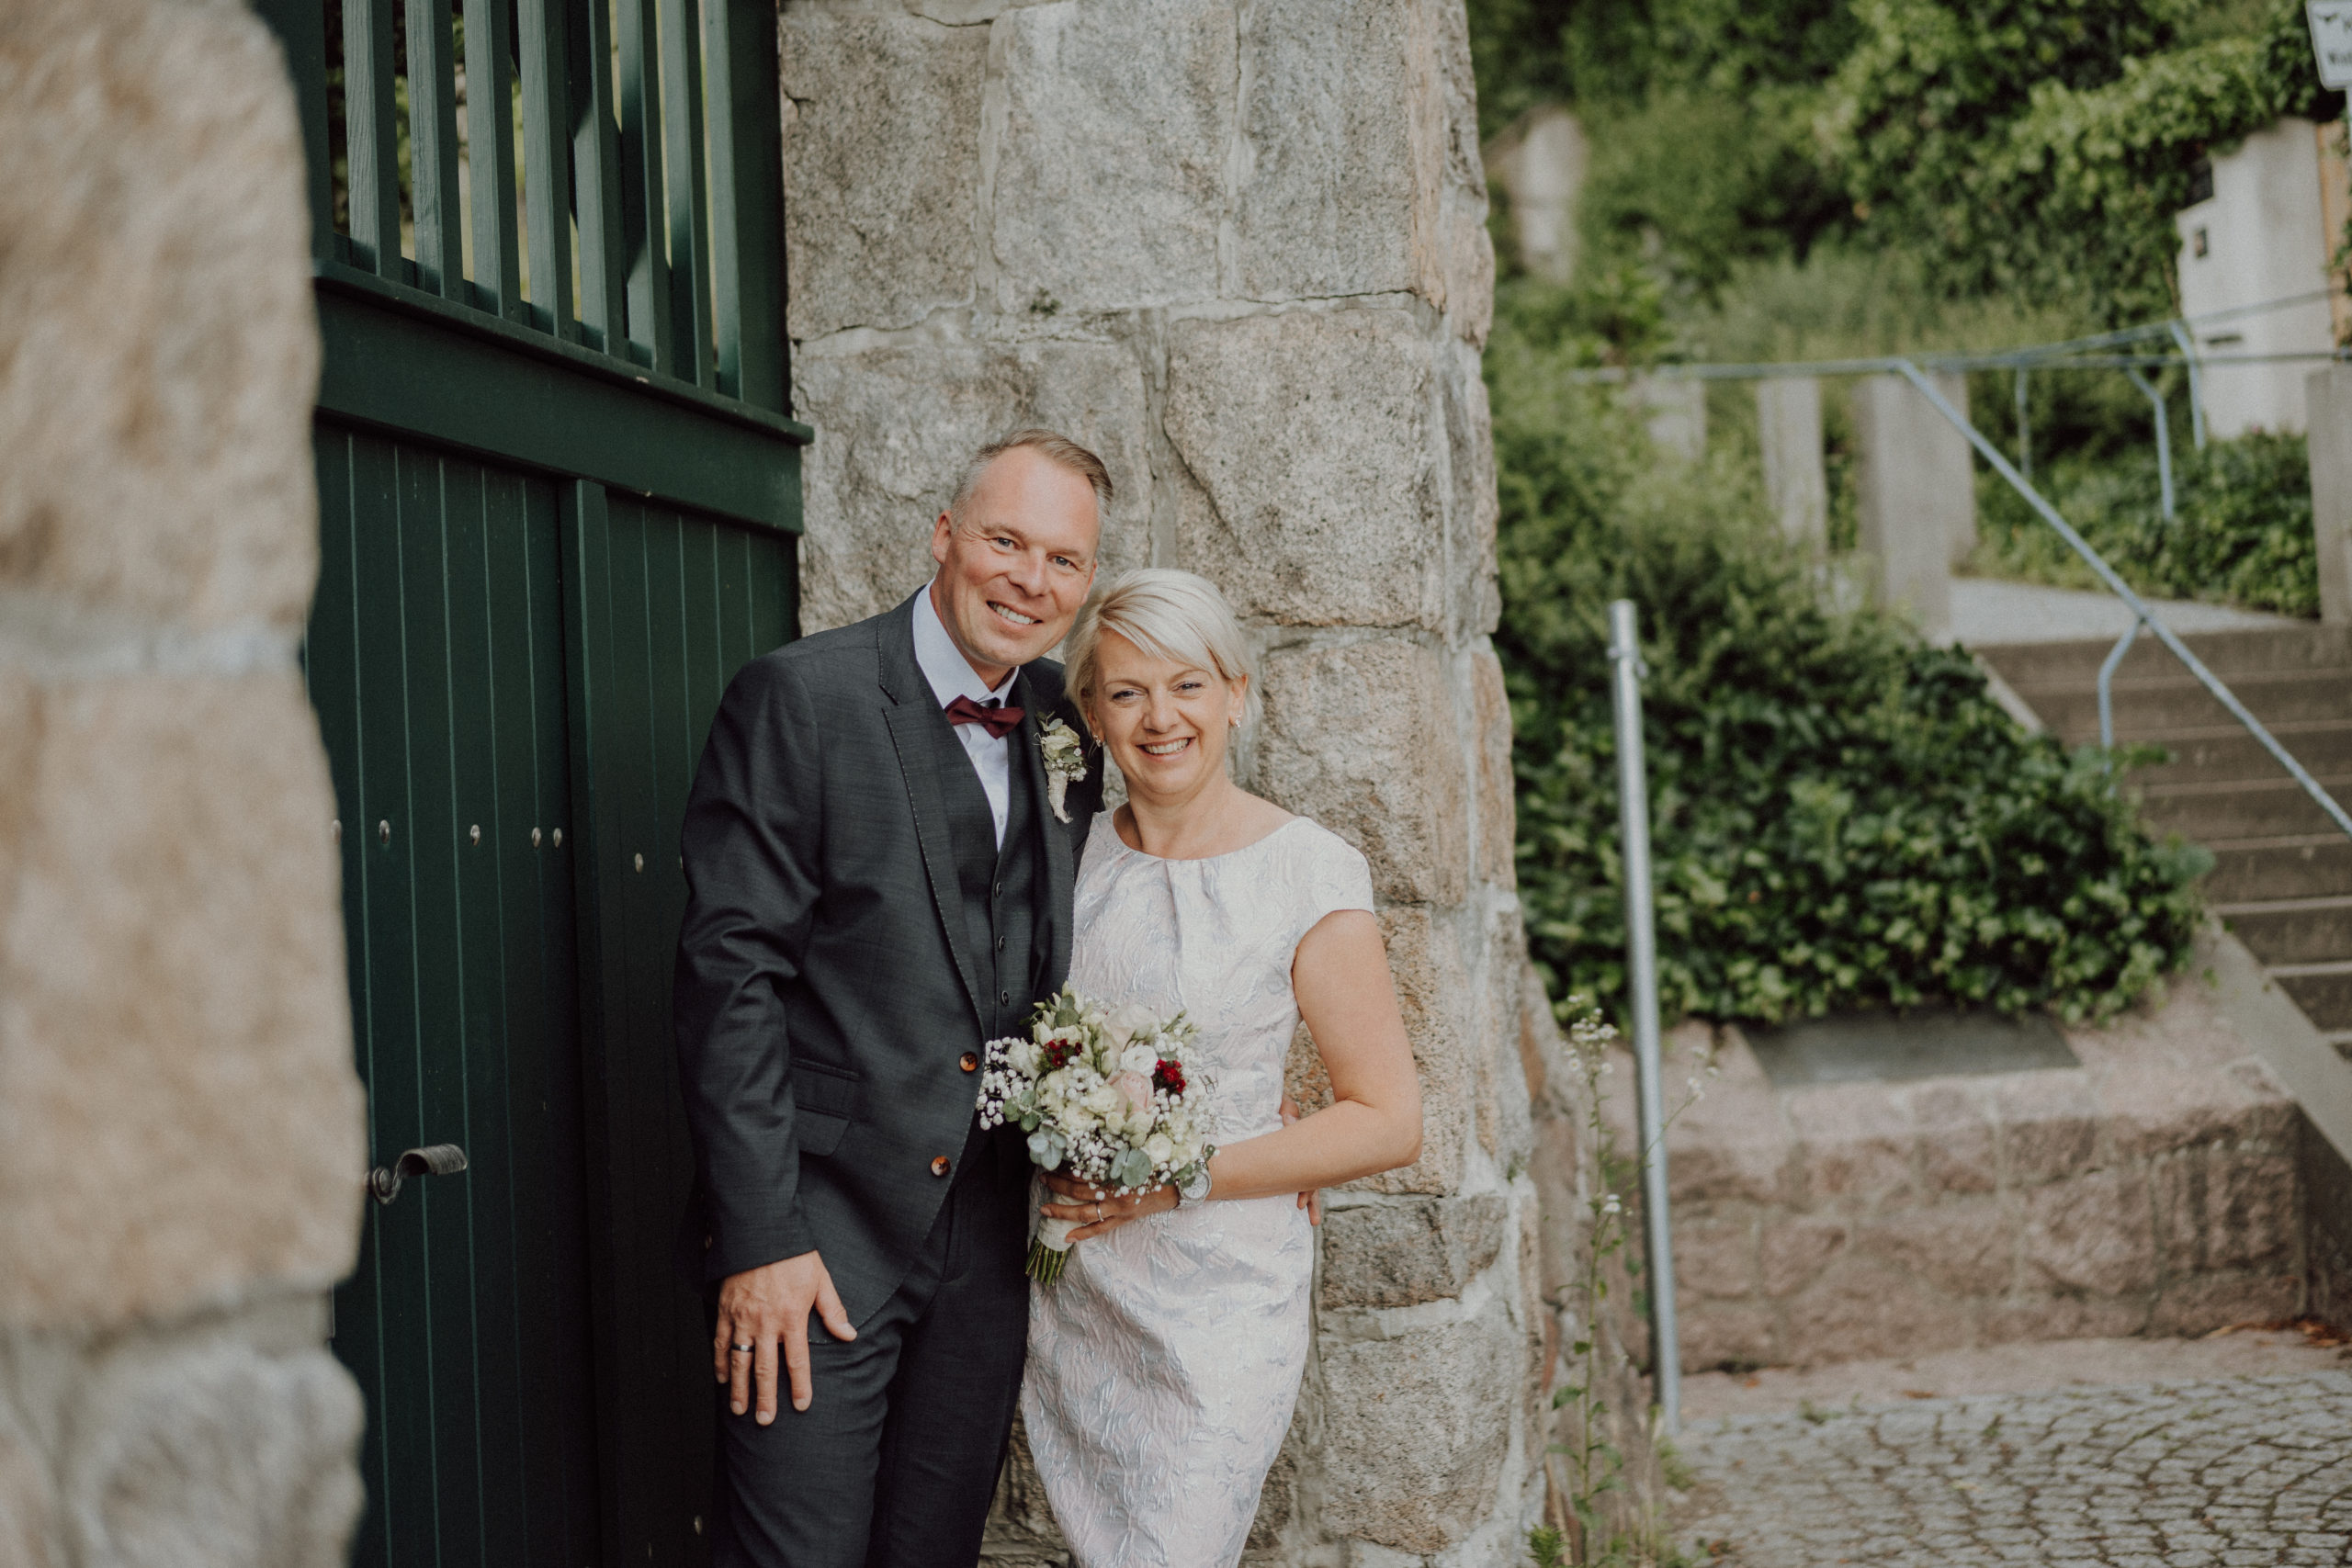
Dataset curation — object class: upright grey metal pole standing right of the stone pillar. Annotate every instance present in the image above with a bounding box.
[1609,600,1681,1432]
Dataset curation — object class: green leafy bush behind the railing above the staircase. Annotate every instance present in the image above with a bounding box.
[1975,434,2319,616]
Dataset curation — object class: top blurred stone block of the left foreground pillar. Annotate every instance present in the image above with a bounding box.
[0,0,318,626]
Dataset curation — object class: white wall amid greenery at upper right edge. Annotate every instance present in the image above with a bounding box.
[2173,120,2340,437]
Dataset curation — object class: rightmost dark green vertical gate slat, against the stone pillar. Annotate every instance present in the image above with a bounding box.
[703,0,786,412]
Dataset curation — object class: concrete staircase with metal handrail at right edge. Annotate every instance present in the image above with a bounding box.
[1978,626,2352,1060]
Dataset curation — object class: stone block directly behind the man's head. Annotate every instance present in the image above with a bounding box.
[793,341,1150,632]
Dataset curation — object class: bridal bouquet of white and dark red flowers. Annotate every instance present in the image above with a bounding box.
[981,985,1216,1283]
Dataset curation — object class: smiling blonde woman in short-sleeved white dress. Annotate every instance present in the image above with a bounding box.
[1021,571,1420,1568]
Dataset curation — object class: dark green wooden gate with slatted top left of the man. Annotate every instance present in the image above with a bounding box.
[261,0,809,1568]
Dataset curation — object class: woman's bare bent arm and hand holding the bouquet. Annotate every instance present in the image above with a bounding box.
[1045,909,1420,1241]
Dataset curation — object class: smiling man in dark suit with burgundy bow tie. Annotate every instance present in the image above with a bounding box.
[675,430,1110,1568]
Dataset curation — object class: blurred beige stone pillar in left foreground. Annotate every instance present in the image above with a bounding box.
[0,0,365,1568]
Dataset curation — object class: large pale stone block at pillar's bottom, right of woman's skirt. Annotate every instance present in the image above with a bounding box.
[1322,1303,1521,1551]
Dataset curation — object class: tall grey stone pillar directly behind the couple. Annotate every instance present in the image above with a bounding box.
[783,0,1543,1563]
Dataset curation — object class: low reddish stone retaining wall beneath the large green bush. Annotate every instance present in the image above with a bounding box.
[1646,976,2305,1371]
